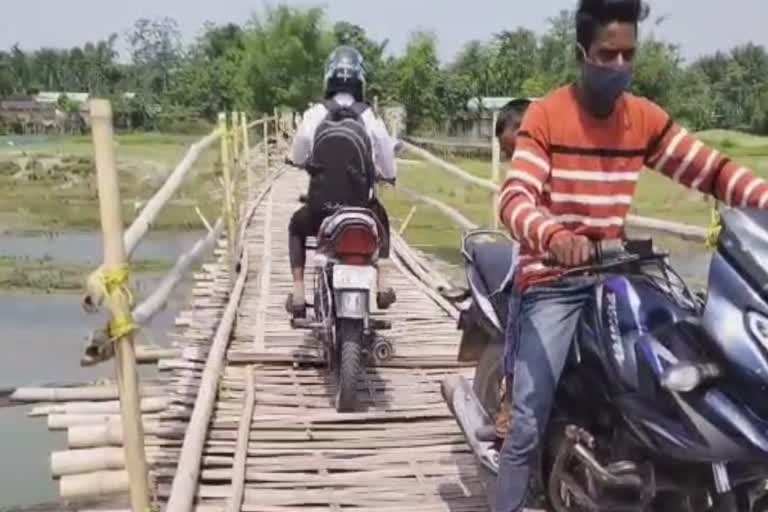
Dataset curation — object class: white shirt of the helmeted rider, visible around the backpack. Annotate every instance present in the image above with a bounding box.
[291,92,397,180]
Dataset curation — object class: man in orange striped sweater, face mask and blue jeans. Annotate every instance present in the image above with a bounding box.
[495,0,768,512]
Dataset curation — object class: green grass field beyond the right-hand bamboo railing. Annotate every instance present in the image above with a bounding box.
[383,130,768,261]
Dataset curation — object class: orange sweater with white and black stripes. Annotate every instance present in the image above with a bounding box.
[499,85,768,289]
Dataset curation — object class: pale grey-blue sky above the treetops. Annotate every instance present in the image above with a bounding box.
[0,0,768,64]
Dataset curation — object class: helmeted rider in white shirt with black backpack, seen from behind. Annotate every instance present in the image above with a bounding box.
[286,46,397,318]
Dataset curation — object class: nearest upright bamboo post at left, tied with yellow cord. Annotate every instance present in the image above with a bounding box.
[90,99,150,512]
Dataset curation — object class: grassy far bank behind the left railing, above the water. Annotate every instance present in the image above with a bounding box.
[0,134,222,231]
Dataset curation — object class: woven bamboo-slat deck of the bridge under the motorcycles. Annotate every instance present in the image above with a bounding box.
[155,164,486,512]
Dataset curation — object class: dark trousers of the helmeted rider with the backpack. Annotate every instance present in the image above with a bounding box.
[288,197,390,269]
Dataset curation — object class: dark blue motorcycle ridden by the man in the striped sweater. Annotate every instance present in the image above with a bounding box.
[442,209,768,512]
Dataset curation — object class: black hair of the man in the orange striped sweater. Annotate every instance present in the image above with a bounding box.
[576,0,650,55]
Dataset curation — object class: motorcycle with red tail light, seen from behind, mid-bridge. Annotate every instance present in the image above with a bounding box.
[286,160,394,412]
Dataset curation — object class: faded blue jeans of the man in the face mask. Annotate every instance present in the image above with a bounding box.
[495,278,594,512]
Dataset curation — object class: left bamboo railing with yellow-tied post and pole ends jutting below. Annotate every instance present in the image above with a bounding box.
[10,99,284,512]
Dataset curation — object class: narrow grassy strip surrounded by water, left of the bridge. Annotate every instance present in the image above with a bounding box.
[0,257,172,293]
